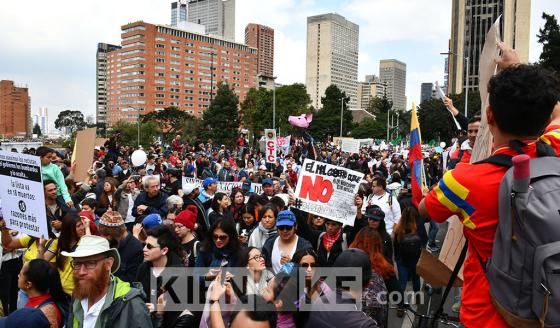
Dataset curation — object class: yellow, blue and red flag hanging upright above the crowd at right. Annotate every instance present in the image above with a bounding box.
[408,103,424,207]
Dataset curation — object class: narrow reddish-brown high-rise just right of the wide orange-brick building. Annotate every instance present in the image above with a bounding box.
[245,23,274,77]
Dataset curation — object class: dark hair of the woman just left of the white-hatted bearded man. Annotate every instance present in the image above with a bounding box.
[24,259,66,303]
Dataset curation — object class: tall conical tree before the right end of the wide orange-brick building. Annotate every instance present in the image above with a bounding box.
[201,82,239,146]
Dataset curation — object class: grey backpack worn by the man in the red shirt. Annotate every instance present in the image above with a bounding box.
[474,141,560,327]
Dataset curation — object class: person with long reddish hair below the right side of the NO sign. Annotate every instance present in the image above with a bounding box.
[350,227,400,327]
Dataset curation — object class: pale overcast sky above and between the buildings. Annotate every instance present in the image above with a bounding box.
[0,0,560,126]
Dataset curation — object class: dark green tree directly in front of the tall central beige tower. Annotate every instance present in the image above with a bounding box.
[309,84,352,140]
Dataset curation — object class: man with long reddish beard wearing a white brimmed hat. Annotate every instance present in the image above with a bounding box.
[62,235,152,328]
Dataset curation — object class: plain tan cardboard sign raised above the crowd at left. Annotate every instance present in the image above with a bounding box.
[71,128,97,181]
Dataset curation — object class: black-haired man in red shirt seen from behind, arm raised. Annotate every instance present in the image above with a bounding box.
[419,44,560,328]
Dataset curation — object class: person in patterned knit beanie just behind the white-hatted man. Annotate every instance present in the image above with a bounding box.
[99,211,143,282]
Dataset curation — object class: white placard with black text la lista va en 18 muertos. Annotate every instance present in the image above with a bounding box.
[0,151,49,238]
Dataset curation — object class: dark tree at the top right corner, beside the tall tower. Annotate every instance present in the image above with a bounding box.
[537,13,560,72]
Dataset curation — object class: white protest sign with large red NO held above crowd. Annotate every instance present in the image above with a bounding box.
[295,159,364,226]
